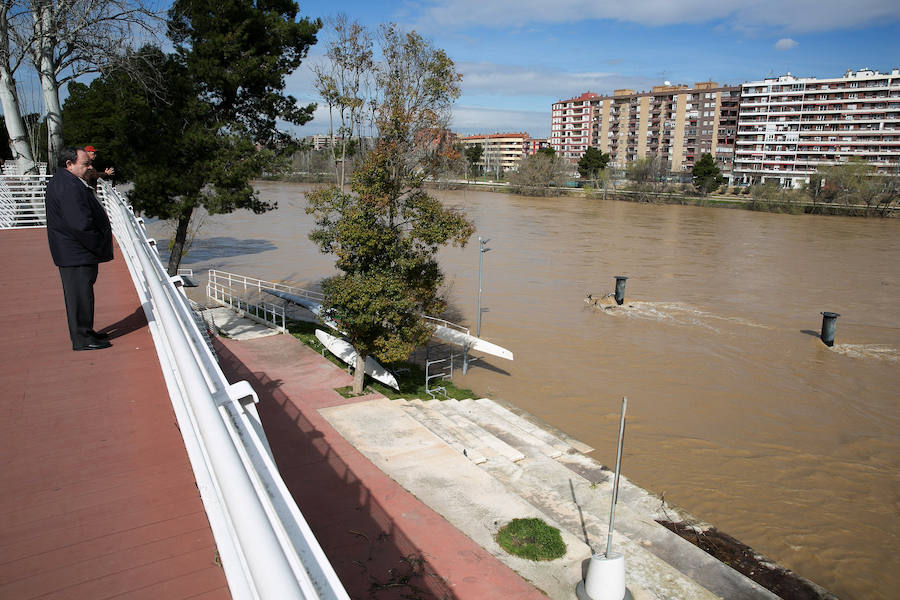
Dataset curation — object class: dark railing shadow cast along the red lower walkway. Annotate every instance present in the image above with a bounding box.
[216,340,457,600]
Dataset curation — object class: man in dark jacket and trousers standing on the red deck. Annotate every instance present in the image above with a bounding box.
[46,147,113,350]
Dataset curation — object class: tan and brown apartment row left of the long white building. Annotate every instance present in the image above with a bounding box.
[550,81,741,174]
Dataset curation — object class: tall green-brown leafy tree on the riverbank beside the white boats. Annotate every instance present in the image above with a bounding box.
[306,25,474,393]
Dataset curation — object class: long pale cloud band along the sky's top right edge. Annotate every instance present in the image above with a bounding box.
[418,0,900,33]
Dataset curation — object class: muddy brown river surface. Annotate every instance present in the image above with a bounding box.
[151,183,900,600]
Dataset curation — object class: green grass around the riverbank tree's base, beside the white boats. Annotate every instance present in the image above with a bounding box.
[287,320,483,400]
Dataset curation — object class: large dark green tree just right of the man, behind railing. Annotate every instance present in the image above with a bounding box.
[66,0,321,274]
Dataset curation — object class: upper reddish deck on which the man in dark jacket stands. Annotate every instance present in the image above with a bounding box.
[0,229,230,600]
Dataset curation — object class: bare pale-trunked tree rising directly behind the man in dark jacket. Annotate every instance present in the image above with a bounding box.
[0,0,161,169]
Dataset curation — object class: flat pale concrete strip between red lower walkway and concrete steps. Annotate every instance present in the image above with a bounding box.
[320,399,716,600]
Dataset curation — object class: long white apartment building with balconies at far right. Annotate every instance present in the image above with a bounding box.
[734,69,900,187]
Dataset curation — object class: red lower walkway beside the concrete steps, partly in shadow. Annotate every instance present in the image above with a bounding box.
[217,335,545,600]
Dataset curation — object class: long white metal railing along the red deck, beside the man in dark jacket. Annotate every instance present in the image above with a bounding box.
[0,176,349,600]
